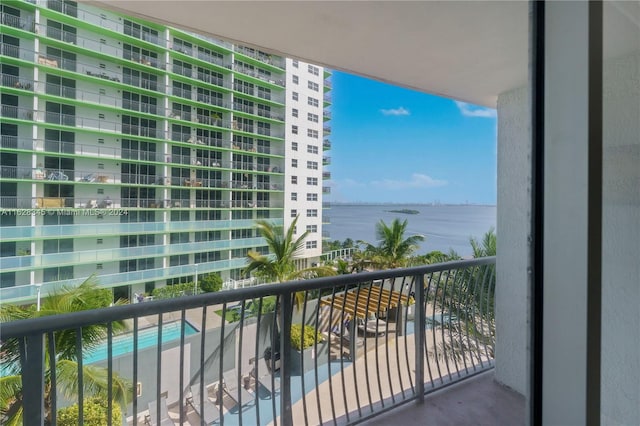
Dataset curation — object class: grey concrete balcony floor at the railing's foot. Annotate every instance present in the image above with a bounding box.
[361,370,526,426]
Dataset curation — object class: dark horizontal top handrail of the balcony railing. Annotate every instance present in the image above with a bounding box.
[0,257,495,340]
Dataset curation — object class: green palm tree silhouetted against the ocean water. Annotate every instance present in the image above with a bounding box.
[363,219,425,268]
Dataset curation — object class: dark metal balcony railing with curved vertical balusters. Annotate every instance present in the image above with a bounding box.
[1,258,495,426]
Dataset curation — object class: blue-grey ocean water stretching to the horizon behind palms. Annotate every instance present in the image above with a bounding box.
[324,204,496,256]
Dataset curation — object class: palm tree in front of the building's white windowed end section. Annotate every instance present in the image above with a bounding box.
[244,216,336,306]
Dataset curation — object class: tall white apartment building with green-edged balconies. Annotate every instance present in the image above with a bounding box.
[0,0,330,303]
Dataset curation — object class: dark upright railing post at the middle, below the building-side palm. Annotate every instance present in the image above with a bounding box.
[279,292,293,426]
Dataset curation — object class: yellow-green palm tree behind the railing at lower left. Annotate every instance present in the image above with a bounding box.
[0,276,132,425]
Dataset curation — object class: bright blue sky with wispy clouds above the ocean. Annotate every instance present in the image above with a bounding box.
[326,71,497,204]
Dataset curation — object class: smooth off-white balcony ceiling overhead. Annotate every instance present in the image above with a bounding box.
[92,0,637,107]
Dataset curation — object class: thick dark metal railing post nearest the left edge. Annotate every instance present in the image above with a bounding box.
[20,333,45,425]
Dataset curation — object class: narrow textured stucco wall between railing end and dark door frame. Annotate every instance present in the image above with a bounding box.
[495,88,531,395]
